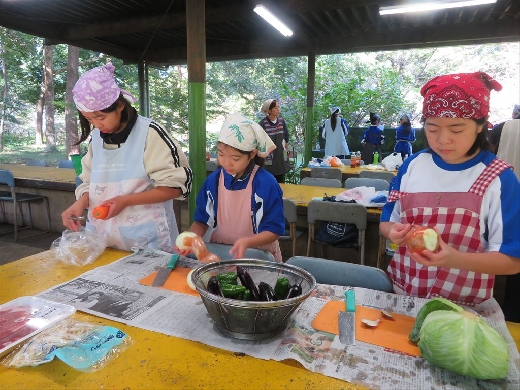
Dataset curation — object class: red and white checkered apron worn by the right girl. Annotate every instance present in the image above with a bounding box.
[388,158,510,304]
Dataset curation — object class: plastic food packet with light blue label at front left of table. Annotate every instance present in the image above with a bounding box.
[2,318,133,372]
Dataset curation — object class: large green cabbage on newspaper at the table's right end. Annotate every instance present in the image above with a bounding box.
[418,309,509,379]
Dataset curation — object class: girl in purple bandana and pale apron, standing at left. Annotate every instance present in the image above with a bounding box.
[61,63,192,252]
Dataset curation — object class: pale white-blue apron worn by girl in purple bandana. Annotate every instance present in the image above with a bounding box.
[87,116,179,253]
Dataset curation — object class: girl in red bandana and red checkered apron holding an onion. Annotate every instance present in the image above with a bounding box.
[380,72,520,304]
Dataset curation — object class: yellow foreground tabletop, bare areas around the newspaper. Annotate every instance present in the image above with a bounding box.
[0,249,360,390]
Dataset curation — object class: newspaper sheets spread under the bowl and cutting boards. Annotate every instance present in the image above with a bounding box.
[38,249,520,389]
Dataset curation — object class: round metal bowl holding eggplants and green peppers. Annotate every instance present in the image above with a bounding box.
[191,259,316,340]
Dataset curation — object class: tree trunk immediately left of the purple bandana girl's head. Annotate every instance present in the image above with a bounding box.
[65,45,81,157]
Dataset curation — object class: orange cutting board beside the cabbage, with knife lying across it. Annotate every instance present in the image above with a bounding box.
[312,301,421,356]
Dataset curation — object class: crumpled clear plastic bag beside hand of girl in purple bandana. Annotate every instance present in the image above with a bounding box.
[51,228,107,266]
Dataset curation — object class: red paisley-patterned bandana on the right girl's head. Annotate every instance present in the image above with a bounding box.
[421,72,502,119]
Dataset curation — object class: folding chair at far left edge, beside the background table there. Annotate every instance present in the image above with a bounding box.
[0,169,51,241]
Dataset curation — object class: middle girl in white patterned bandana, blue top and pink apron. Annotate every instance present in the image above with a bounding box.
[177,113,285,262]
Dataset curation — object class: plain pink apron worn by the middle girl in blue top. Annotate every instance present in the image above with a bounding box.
[210,165,282,263]
